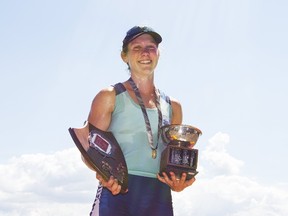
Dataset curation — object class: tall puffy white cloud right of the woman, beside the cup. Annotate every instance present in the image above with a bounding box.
[173,132,288,216]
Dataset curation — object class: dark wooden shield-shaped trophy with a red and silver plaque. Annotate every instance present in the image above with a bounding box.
[69,121,128,193]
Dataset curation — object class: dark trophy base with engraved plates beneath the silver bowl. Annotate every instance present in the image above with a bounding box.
[160,145,198,180]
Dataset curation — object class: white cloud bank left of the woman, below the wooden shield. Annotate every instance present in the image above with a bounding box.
[0,148,98,216]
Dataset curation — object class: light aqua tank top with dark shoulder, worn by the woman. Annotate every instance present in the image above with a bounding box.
[109,83,172,178]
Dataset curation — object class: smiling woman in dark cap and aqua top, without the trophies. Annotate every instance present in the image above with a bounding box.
[88,26,195,216]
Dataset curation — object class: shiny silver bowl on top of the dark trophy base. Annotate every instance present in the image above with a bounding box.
[161,124,202,148]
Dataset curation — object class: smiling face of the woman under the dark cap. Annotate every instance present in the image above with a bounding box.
[121,34,160,75]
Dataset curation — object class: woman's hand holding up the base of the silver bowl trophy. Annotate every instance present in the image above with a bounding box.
[157,172,196,192]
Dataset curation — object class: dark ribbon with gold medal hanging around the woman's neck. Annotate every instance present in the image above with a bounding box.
[128,77,162,159]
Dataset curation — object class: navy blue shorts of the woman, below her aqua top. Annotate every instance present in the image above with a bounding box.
[90,175,173,216]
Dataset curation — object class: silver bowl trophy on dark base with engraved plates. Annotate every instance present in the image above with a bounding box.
[160,124,202,180]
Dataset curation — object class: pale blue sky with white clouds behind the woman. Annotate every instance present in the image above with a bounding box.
[0,0,288,216]
